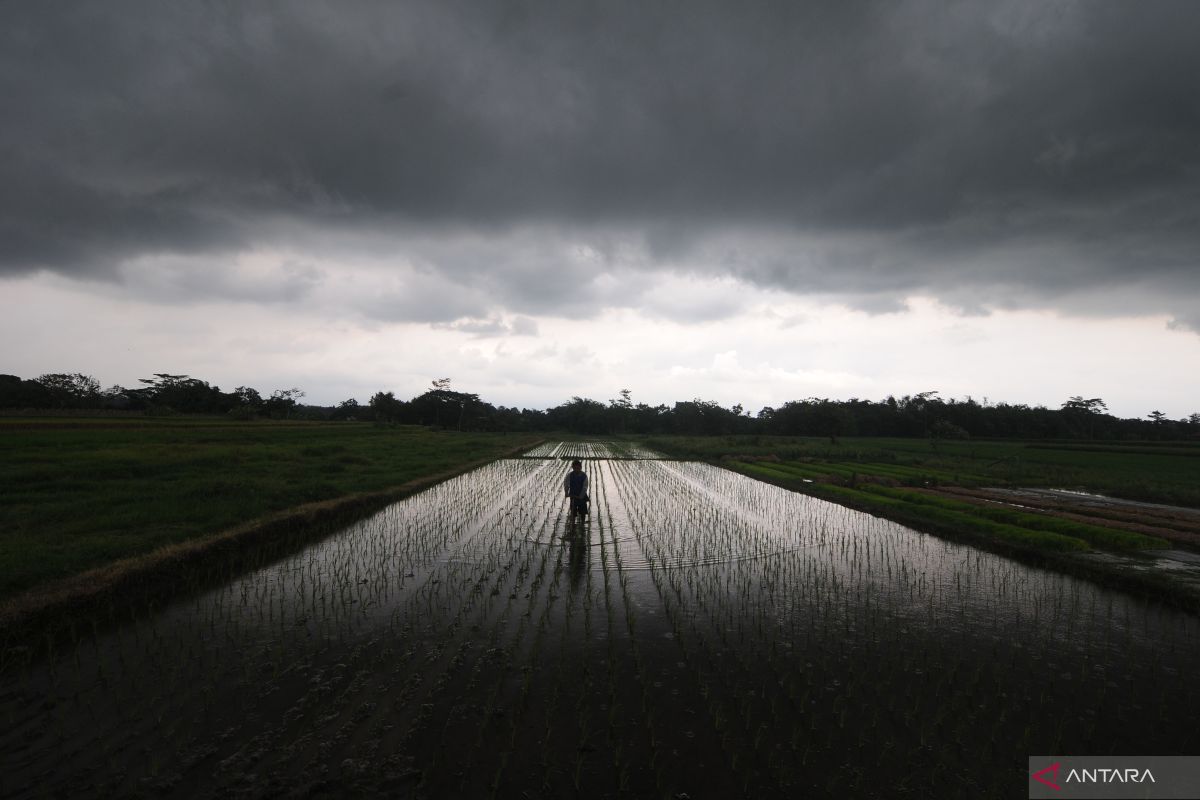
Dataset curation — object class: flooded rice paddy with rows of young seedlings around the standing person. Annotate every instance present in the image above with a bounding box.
[0,443,1200,798]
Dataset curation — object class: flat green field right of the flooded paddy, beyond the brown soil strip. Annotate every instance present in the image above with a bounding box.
[646,435,1200,507]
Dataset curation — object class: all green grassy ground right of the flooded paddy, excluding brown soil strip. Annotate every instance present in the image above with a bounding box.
[647,437,1200,552]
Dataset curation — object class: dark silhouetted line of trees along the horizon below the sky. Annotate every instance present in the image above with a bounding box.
[0,373,1200,440]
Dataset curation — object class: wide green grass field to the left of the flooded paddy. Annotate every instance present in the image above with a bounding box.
[0,417,532,599]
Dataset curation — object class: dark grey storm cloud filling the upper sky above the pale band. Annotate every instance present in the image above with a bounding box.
[0,0,1200,324]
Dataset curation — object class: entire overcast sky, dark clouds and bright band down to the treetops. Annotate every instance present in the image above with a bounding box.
[0,0,1200,417]
